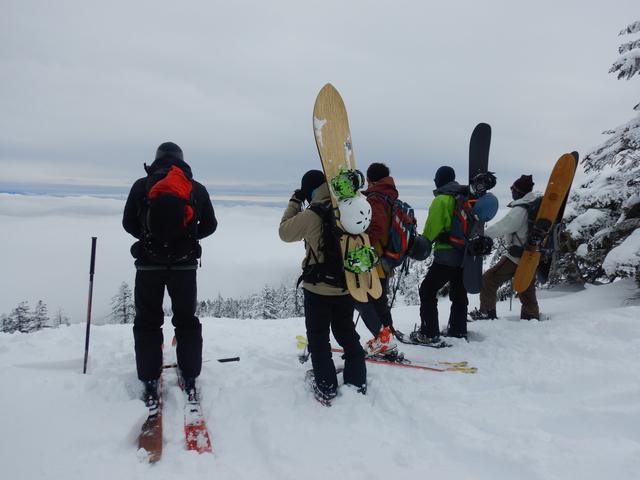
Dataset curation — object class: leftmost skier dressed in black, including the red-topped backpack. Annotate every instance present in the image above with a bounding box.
[122,142,218,413]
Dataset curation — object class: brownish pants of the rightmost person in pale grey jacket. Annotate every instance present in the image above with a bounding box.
[480,257,540,320]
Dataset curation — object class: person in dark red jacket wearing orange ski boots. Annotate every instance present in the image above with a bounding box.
[356,163,398,355]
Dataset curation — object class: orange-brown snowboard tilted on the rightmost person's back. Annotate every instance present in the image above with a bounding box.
[513,153,576,292]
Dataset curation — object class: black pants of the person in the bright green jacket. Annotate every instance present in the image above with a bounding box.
[419,262,469,338]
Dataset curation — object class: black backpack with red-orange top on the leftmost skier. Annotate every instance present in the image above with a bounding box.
[141,166,200,264]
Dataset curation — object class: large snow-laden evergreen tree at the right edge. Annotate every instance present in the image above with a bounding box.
[559,21,640,286]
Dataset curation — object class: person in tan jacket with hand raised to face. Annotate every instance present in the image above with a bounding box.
[278,170,367,403]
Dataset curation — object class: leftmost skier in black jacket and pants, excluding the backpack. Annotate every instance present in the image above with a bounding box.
[122,142,218,410]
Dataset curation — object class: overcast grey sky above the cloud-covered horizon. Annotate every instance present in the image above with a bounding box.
[0,0,640,204]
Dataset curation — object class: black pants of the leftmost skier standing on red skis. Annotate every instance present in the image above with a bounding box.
[133,269,202,381]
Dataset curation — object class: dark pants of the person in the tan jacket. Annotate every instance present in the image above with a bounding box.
[304,290,367,394]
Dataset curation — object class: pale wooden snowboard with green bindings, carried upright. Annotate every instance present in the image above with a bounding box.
[313,83,382,302]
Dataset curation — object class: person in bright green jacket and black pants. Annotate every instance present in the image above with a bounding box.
[410,166,469,344]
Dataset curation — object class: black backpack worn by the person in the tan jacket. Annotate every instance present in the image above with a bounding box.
[298,202,347,290]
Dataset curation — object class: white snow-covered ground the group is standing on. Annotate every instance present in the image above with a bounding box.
[0,281,640,480]
